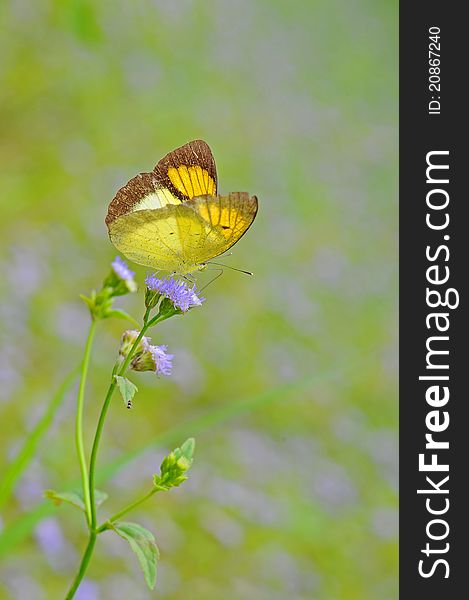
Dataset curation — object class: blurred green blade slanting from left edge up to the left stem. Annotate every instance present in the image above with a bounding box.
[0,365,80,508]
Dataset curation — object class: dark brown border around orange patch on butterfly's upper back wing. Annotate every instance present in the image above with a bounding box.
[153,140,218,202]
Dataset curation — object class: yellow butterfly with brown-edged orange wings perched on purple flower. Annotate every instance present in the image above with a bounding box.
[106,140,257,275]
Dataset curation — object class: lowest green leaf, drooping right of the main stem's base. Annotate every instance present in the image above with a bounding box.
[112,522,160,590]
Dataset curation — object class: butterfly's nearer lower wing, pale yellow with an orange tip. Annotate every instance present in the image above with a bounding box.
[109,192,257,275]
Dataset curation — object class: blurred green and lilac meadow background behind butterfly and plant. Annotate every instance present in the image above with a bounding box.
[0,0,397,600]
